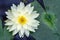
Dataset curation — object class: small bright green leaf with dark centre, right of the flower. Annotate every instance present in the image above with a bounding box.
[41,12,56,30]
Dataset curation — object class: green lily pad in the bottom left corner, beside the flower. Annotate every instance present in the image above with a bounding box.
[0,20,13,40]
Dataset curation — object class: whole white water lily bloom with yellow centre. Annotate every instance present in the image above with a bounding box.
[5,2,39,37]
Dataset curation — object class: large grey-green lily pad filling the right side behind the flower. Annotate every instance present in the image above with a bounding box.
[31,0,60,40]
